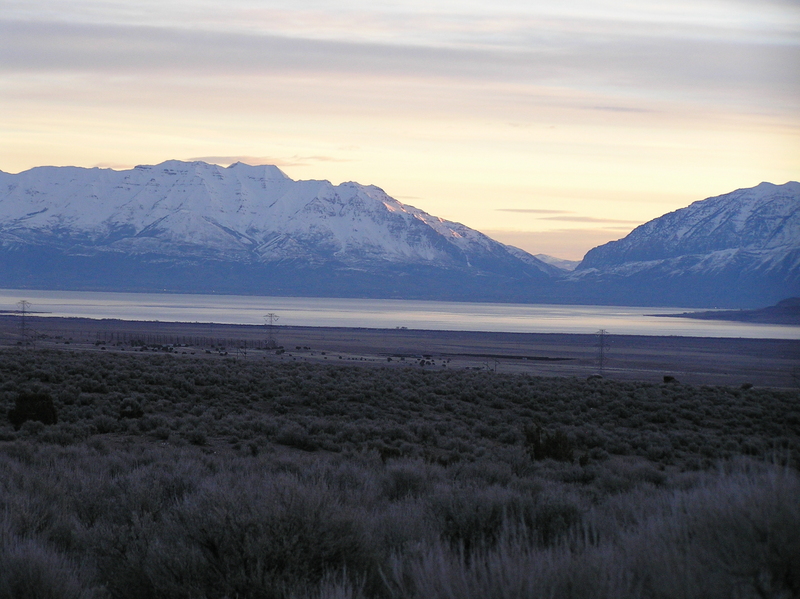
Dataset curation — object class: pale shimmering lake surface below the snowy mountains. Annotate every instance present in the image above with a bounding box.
[0,289,800,339]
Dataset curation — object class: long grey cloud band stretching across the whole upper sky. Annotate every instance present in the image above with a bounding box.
[0,19,800,113]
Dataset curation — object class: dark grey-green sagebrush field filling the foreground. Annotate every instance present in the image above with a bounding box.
[0,351,800,599]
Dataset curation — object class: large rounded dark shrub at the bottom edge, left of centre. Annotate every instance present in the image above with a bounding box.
[97,476,377,599]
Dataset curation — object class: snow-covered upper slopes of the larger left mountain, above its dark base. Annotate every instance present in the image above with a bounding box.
[0,161,554,276]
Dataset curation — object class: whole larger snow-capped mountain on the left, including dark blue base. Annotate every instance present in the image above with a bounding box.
[0,161,558,296]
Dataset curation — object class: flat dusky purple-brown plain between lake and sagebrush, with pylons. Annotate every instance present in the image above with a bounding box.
[0,315,800,389]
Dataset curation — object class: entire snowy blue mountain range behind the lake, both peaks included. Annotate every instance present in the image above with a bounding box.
[0,161,800,307]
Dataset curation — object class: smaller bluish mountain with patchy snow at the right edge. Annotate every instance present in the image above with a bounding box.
[570,182,800,307]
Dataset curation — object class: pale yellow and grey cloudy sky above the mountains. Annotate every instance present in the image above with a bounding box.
[0,0,800,259]
